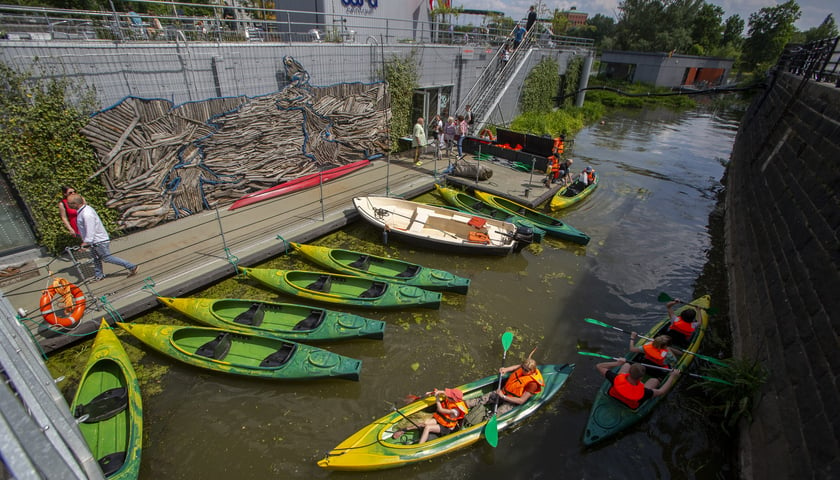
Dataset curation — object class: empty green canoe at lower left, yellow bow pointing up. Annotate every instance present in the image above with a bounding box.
[70,318,143,479]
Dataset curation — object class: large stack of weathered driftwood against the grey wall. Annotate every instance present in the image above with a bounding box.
[82,60,391,228]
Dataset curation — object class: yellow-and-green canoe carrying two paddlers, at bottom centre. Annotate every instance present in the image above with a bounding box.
[318,365,575,470]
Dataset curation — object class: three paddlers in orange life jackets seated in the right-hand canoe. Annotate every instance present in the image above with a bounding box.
[595,299,700,410]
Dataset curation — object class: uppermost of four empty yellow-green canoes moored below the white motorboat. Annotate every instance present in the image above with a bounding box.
[290,243,470,293]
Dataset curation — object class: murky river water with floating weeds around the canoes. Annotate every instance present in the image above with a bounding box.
[113,107,738,480]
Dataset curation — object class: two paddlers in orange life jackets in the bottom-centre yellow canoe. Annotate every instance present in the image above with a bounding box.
[393,348,545,443]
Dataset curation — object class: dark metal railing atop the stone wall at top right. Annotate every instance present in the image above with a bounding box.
[779,37,840,88]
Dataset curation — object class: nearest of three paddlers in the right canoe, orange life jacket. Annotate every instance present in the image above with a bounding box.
[595,358,680,410]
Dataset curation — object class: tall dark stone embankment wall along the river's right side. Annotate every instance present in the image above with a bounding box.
[726,74,840,479]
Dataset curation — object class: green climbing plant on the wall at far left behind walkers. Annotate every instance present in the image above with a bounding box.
[0,64,117,253]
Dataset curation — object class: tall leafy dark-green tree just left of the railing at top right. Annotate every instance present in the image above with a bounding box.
[741,0,802,70]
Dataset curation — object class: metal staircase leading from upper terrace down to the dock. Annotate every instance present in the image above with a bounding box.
[456,25,535,134]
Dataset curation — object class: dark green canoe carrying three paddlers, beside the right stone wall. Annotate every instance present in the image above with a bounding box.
[583,295,710,445]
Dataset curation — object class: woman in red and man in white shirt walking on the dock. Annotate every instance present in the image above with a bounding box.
[58,186,139,282]
